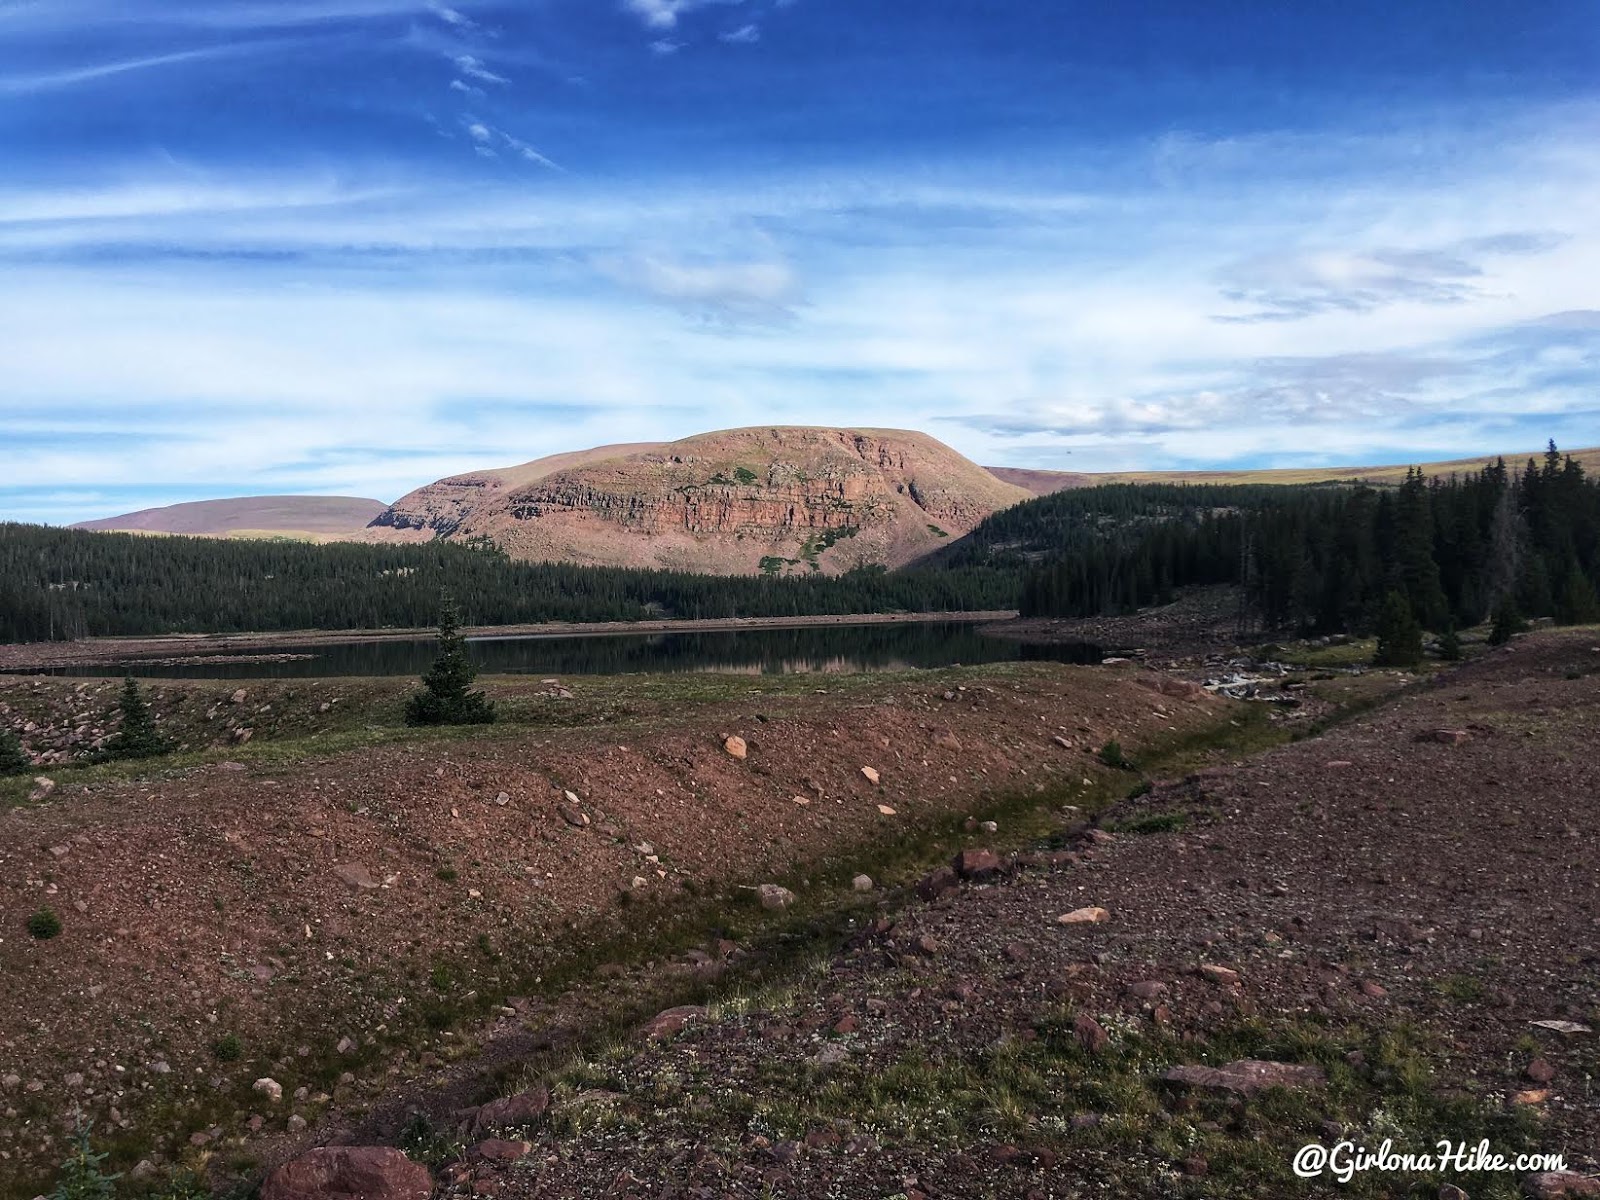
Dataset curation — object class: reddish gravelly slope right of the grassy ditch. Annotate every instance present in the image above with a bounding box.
[428,630,1600,1200]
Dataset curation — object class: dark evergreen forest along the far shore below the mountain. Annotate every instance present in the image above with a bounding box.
[0,523,1019,642]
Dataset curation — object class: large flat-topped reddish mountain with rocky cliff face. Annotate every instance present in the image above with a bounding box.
[366,427,1029,574]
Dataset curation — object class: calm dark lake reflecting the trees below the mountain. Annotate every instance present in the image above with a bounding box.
[40,621,1104,678]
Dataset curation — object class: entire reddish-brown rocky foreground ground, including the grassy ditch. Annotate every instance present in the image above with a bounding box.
[0,630,1600,1200]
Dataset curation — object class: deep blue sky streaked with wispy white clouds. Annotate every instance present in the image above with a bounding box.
[0,0,1600,522]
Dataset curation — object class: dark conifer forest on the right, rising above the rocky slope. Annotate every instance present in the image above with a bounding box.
[1006,442,1600,634]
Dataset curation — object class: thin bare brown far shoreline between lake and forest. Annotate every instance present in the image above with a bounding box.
[0,610,1018,672]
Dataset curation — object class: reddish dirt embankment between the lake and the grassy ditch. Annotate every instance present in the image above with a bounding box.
[0,664,1229,1196]
